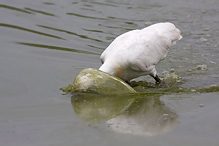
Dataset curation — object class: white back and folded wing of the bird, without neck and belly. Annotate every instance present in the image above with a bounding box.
[101,23,182,71]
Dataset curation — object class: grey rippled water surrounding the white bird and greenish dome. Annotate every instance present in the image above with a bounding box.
[0,0,219,146]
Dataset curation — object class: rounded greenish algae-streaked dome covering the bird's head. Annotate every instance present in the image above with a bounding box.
[71,68,136,94]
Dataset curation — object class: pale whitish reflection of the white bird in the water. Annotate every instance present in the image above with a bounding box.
[107,96,179,136]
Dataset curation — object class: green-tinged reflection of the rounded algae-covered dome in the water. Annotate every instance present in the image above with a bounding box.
[71,93,135,123]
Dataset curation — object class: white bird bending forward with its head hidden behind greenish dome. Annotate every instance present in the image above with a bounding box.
[99,22,182,83]
